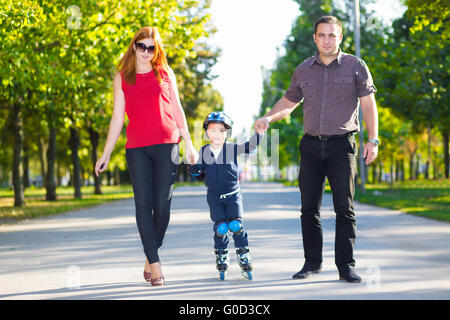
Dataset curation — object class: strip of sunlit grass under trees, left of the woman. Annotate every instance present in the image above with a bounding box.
[0,183,202,224]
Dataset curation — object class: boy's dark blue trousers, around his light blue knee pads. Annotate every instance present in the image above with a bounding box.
[206,190,248,249]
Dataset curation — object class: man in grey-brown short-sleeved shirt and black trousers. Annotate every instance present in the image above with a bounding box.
[255,16,379,282]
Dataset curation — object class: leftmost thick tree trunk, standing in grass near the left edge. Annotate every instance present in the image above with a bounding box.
[13,104,25,207]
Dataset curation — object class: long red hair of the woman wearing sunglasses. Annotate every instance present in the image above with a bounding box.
[117,27,169,85]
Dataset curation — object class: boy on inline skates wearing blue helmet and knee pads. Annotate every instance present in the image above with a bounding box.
[189,112,261,280]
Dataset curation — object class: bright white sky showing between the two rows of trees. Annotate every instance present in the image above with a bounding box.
[209,0,404,136]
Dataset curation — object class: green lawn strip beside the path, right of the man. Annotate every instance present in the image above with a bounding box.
[283,179,450,222]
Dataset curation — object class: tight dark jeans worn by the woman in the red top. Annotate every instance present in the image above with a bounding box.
[126,143,178,263]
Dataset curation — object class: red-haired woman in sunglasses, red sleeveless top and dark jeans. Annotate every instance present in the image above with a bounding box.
[95,27,198,286]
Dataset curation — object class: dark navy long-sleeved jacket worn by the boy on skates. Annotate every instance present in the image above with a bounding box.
[189,133,262,195]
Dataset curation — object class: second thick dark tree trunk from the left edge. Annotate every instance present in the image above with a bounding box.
[45,113,56,201]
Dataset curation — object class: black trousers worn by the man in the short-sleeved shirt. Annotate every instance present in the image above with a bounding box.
[299,135,357,272]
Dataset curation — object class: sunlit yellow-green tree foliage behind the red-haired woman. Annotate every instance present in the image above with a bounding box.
[0,0,221,206]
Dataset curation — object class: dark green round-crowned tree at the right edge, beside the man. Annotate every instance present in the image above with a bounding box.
[372,11,450,178]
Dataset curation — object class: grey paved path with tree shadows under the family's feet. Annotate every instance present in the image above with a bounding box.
[0,183,450,300]
